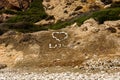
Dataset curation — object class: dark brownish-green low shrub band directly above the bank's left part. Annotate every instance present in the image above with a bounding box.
[0,22,47,34]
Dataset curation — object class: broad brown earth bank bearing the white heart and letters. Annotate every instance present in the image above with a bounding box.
[0,18,120,67]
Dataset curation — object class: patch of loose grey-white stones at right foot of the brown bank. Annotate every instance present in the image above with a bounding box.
[83,58,120,70]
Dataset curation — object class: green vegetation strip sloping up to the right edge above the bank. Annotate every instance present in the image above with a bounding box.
[48,7,120,29]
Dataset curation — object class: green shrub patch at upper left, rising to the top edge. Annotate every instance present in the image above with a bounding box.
[6,0,47,23]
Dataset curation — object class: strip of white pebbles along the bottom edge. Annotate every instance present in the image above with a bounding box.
[0,71,120,80]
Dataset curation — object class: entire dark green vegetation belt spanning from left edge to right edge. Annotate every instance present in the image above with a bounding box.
[0,0,120,34]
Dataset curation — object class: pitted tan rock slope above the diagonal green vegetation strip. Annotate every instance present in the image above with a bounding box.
[43,0,119,22]
